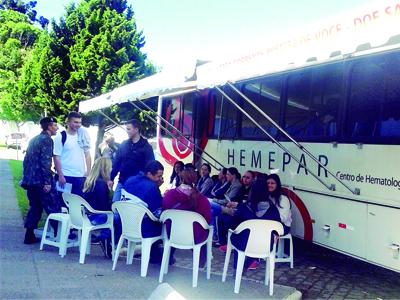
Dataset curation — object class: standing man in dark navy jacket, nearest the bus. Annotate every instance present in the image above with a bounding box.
[108,119,154,202]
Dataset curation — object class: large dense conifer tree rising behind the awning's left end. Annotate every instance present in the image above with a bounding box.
[24,0,154,148]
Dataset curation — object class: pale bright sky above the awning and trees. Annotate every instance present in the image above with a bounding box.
[37,0,371,70]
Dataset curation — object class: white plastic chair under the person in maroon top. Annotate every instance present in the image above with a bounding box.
[159,209,213,287]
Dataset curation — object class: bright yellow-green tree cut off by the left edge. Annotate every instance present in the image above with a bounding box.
[0,10,41,122]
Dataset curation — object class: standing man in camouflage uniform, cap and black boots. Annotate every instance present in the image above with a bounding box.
[21,117,61,244]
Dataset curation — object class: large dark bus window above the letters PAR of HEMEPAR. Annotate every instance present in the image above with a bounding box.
[285,65,343,142]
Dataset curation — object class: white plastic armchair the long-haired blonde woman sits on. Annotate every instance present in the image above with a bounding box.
[63,193,114,264]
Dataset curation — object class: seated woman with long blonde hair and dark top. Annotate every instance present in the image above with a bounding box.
[83,157,112,258]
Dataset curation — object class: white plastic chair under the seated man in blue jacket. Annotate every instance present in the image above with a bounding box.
[112,199,162,277]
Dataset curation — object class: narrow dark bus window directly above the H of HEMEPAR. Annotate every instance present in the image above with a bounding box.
[213,93,238,139]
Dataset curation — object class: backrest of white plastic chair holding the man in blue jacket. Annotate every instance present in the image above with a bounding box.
[112,201,157,239]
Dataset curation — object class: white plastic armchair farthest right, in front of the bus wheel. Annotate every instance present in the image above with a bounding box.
[222,220,283,296]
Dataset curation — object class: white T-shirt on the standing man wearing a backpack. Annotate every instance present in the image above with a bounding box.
[54,132,86,177]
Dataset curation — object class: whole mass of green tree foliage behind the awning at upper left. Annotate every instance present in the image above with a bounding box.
[0,0,155,142]
